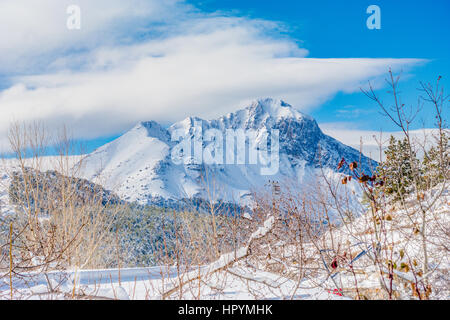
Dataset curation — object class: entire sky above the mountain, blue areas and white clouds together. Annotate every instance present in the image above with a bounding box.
[0,0,450,151]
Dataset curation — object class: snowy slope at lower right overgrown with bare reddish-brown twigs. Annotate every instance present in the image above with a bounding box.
[250,185,450,300]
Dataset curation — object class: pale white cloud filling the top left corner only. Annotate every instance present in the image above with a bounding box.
[0,0,189,73]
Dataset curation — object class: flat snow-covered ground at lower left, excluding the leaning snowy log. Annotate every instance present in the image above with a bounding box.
[0,267,345,300]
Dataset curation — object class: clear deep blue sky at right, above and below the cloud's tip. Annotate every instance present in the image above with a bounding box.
[191,0,450,131]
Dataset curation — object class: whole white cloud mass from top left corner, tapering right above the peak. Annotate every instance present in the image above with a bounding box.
[0,0,426,151]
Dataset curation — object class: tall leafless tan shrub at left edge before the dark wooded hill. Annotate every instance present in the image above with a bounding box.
[0,123,120,300]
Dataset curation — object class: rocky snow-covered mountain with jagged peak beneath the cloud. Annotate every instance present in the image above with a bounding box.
[83,99,375,204]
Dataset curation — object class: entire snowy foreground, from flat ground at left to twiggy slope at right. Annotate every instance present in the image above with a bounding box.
[0,184,450,299]
